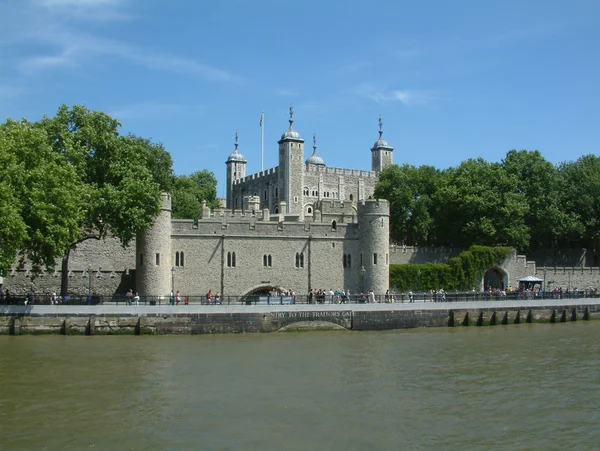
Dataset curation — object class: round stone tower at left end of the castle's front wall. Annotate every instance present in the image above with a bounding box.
[135,193,173,296]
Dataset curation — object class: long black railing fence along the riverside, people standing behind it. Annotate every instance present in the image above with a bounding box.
[0,289,600,306]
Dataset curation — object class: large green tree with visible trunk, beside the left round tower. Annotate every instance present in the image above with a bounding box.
[41,105,172,295]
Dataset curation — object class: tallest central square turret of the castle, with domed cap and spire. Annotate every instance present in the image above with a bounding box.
[278,105,304,219]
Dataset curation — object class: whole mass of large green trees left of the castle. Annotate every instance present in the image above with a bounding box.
[0,105,173,294]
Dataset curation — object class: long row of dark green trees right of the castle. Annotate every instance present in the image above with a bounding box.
[375,150,600,263]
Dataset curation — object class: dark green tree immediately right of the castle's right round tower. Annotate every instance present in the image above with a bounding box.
[375,164,440,244]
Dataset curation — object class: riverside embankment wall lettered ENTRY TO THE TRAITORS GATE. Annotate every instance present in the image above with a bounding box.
[0,300,600,335]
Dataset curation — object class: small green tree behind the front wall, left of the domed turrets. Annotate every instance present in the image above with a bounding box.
[171,169,217,219]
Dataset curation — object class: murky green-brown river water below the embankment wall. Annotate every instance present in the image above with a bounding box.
[0,321,600,451]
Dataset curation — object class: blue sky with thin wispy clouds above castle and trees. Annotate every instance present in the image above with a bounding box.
[0,0,600,195]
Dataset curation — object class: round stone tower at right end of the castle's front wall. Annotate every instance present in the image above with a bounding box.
[356,199,390,294]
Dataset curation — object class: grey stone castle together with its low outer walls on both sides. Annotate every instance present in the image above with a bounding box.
[0,107,600,296]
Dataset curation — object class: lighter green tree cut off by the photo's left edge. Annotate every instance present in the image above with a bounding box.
[0,120,89,274]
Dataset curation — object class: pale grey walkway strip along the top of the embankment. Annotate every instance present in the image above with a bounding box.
[0,298,600,316]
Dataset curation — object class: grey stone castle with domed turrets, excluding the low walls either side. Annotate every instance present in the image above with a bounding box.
[136,107,393,296]
